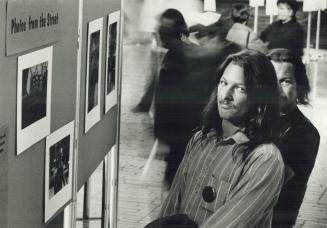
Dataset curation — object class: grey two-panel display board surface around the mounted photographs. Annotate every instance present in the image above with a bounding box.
[0,0,120,228]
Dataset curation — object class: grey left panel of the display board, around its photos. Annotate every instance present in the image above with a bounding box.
[0,0,78,228]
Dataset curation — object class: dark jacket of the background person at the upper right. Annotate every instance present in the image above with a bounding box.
[260,18,305,56]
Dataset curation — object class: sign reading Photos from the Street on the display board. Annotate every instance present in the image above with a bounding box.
[5,0,62,56]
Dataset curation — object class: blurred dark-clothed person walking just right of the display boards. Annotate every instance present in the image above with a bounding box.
[154,9,194,187]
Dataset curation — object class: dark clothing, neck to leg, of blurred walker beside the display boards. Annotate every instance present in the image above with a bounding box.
[154,40,195,185]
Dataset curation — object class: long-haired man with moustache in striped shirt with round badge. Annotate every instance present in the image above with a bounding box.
[147,51,284,228]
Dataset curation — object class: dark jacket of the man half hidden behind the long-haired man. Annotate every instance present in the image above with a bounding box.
[272,108,320,228]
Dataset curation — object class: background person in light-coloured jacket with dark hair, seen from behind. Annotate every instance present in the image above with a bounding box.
[226,4,268,54]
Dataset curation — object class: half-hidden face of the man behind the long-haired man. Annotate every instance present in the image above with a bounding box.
[271,61,297,114]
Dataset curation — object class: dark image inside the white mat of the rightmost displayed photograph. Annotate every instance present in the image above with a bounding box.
[107,22,117,95]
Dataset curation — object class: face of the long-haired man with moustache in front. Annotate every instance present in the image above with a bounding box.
[217,62,249,127]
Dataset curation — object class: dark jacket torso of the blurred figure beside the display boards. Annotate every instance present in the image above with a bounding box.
[154,41,192,145]
